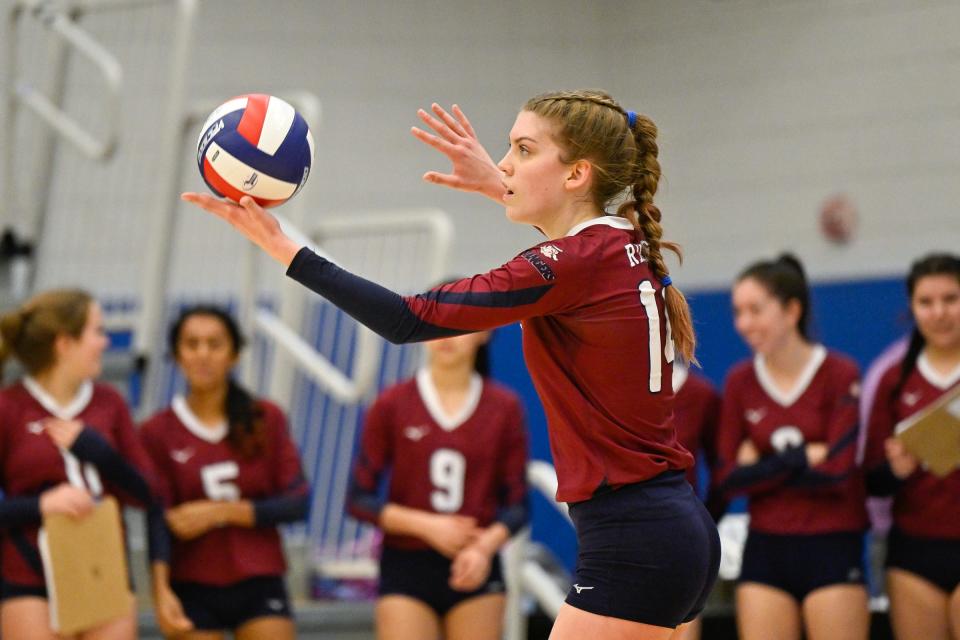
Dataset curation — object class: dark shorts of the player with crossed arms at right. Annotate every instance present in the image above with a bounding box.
[739,530,864,603]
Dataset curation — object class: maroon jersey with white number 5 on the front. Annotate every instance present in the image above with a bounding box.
[140,396,308,586]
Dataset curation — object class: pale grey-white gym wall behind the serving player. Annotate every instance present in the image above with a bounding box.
[3,0,960,296]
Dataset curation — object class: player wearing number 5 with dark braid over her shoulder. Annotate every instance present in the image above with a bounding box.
[140,306,309,640]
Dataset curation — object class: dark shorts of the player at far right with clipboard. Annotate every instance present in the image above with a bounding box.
[886,527,960,595]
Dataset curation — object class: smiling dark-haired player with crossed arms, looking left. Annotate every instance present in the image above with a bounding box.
[718,255,869,640]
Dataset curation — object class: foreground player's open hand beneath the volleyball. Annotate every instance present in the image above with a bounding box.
[180,193,300,267]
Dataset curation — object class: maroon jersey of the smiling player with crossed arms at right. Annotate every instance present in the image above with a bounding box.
[718,345,867,535]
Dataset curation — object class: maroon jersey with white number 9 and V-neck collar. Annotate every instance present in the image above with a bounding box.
[349,369,527,549]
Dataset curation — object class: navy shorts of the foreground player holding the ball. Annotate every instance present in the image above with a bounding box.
[566,471,720,628]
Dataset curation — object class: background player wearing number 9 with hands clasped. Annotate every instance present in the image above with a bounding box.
[349,332,528,640]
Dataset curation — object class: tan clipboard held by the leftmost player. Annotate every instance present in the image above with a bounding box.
[38,496,133,635]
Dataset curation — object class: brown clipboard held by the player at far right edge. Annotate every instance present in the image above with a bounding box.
[895,385,960,478]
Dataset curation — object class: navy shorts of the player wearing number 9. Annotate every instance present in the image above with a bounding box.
[379,547,506,618]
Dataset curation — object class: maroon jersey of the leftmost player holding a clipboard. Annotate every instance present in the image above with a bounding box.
[0,378,150,586]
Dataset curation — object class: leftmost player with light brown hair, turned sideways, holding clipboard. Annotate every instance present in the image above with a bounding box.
[0,290,165,640]
